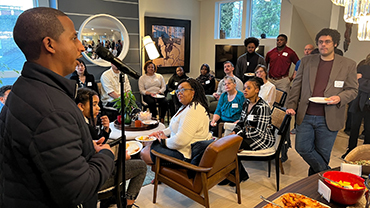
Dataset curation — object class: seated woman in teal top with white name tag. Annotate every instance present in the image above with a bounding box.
[209,76,245,137]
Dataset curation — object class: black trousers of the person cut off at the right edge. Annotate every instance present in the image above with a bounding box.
[347,111,370,152]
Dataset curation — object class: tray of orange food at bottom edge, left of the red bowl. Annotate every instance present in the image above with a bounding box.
[263,193,330,208]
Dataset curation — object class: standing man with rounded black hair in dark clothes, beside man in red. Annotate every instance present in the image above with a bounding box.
[235,37,266,83]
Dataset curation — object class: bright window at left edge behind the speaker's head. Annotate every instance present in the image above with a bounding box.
[0,0,34,86]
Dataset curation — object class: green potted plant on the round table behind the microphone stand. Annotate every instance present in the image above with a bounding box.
[113,91,139,124]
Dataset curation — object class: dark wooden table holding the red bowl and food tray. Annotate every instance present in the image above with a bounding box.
[255,168,365,208]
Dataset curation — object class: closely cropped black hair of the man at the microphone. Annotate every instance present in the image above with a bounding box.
[13,7,67,61]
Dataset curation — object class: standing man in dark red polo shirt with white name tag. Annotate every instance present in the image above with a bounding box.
[266,34,299,93]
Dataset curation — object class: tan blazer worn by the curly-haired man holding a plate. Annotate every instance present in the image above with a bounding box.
[286,54,358,131]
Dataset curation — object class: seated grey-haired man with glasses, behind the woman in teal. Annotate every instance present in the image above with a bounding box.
[206,61,243,113]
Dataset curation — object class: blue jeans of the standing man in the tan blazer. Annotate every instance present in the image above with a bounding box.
[295,115,338,175]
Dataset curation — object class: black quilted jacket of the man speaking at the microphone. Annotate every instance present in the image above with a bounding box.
[0,62,114,208]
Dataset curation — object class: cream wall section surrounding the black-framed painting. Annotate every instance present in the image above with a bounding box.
[139,0,200,80]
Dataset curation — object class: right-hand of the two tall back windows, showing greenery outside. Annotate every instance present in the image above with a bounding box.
[250,0,281,38]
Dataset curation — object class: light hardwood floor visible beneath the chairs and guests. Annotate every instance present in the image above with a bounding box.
[131,131,352,208]
